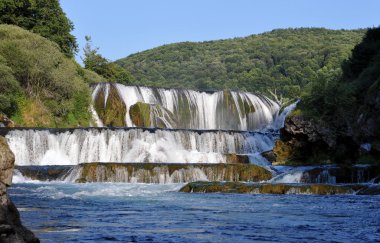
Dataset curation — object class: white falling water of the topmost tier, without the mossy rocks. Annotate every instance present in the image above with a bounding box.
[92,83,280,131]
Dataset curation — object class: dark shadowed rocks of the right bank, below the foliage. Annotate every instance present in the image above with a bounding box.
[270,111,380,165]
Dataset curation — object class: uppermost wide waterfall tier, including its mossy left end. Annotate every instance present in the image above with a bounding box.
[92,83,280,131]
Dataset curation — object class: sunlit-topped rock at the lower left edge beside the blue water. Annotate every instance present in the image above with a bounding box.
[0,137,39,243]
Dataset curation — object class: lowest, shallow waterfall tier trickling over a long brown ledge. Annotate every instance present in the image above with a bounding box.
[14,163,271,184]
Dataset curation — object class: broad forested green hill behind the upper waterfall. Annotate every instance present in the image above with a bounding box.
[116,28,365,97]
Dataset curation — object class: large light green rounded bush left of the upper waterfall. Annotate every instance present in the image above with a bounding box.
[0,25,90,127]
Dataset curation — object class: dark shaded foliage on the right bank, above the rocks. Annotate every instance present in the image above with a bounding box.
[300,28,380,126]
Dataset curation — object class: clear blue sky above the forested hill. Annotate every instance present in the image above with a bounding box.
[61,0,380,61]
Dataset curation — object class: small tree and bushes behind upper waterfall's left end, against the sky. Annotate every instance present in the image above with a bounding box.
[83,36,132,84]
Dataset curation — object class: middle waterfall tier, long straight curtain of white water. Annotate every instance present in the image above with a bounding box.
[6,128,275,166]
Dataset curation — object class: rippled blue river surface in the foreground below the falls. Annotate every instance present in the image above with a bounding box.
[9,183,380,242]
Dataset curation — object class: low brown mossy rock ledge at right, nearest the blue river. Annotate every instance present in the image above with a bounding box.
[180,182,380,195]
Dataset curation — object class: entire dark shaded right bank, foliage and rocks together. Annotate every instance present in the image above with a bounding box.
[275,28,380,164]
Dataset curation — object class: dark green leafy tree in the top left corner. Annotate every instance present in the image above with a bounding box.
[0,0,78,57]
